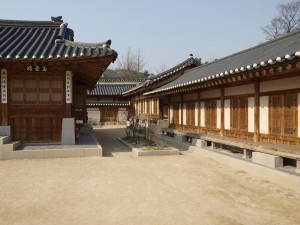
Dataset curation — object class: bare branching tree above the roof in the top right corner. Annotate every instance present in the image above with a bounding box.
[262,0,300,40]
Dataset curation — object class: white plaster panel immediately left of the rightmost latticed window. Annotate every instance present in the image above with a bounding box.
[259,96,269,134]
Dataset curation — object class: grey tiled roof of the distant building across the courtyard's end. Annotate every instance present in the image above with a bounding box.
[88,84,135,95]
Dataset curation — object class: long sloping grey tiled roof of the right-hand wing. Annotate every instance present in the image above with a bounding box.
[144,32,300,95]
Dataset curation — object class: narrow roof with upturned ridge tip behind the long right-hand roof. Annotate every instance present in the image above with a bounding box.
[123,54,196,94]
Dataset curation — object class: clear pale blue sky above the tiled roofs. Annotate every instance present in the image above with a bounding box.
[0,0,290,73]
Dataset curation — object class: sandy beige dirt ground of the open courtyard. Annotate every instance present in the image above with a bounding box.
[0,125,300,225]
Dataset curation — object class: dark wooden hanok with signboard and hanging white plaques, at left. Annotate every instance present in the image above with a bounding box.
[0,17,117,142]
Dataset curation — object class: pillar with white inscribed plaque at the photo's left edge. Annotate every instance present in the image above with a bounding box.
[0,69,8,126]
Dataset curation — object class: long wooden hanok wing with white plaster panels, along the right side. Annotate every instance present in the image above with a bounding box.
[124,32,300,165]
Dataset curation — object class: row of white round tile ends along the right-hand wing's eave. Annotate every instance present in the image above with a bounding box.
[143,51,300,95]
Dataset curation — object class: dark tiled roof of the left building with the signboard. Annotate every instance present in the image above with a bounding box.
[0,18,117,60]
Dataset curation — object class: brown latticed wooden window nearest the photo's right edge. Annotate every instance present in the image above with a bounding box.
[270,94,296,135]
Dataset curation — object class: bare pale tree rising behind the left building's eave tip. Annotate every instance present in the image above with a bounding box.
[116,48,146,73]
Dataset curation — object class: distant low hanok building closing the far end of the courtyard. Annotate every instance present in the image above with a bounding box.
[87,77,145,125]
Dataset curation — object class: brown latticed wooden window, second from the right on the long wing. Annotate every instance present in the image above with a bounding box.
[231,98,248,130]
